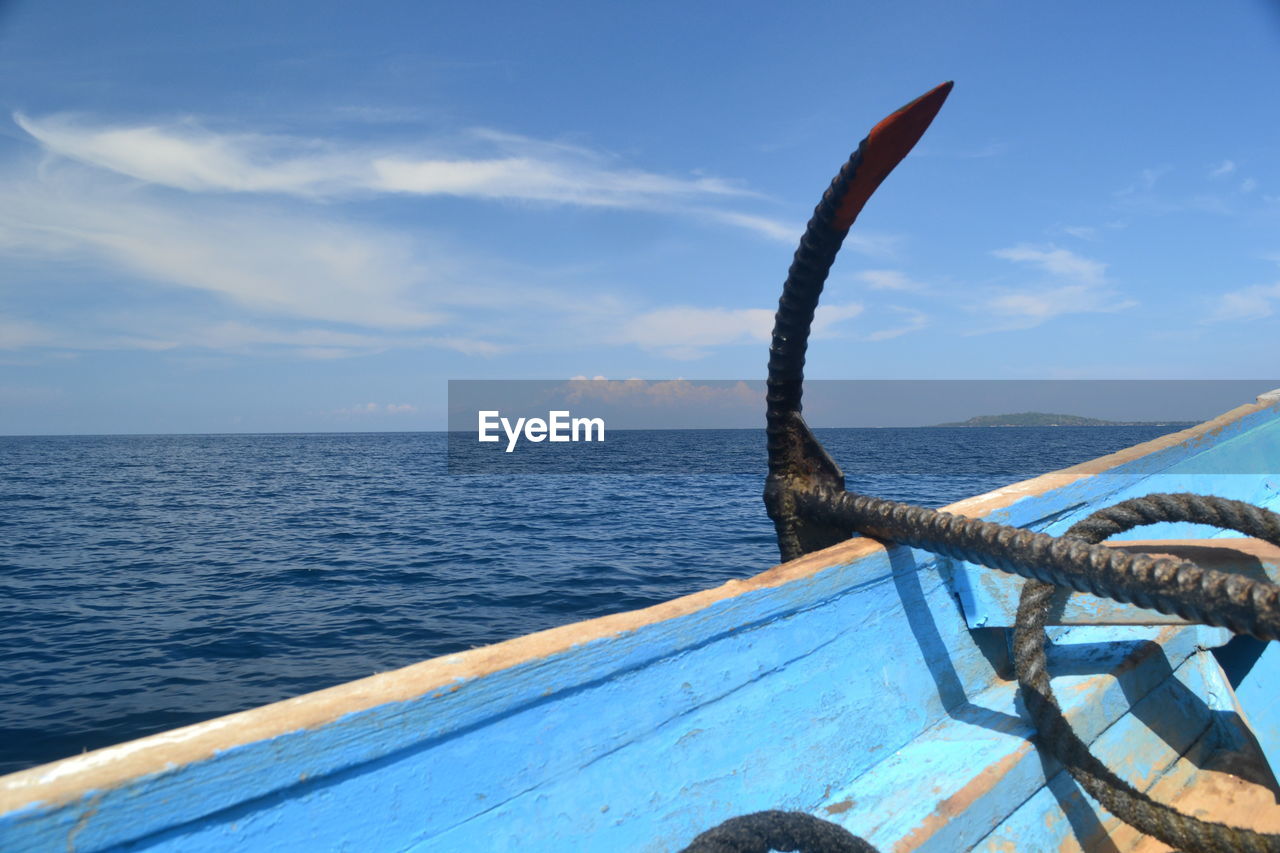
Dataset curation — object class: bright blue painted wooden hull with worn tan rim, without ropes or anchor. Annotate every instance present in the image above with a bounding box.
[0,400,1280,852]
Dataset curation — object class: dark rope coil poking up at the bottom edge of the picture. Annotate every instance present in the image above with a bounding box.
[681,812,877,853]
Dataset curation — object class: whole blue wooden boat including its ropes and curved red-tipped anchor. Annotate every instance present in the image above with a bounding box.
[0,85,1280,853]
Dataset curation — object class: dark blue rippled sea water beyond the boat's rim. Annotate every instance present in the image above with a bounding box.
[0,427,1174,774]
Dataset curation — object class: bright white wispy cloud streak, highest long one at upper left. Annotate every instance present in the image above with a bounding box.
[14,114,755,211]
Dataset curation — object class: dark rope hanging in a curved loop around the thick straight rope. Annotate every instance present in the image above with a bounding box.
[1014,494,1280,853]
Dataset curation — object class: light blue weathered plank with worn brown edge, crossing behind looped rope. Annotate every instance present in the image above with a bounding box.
[817,626,1225,853]
